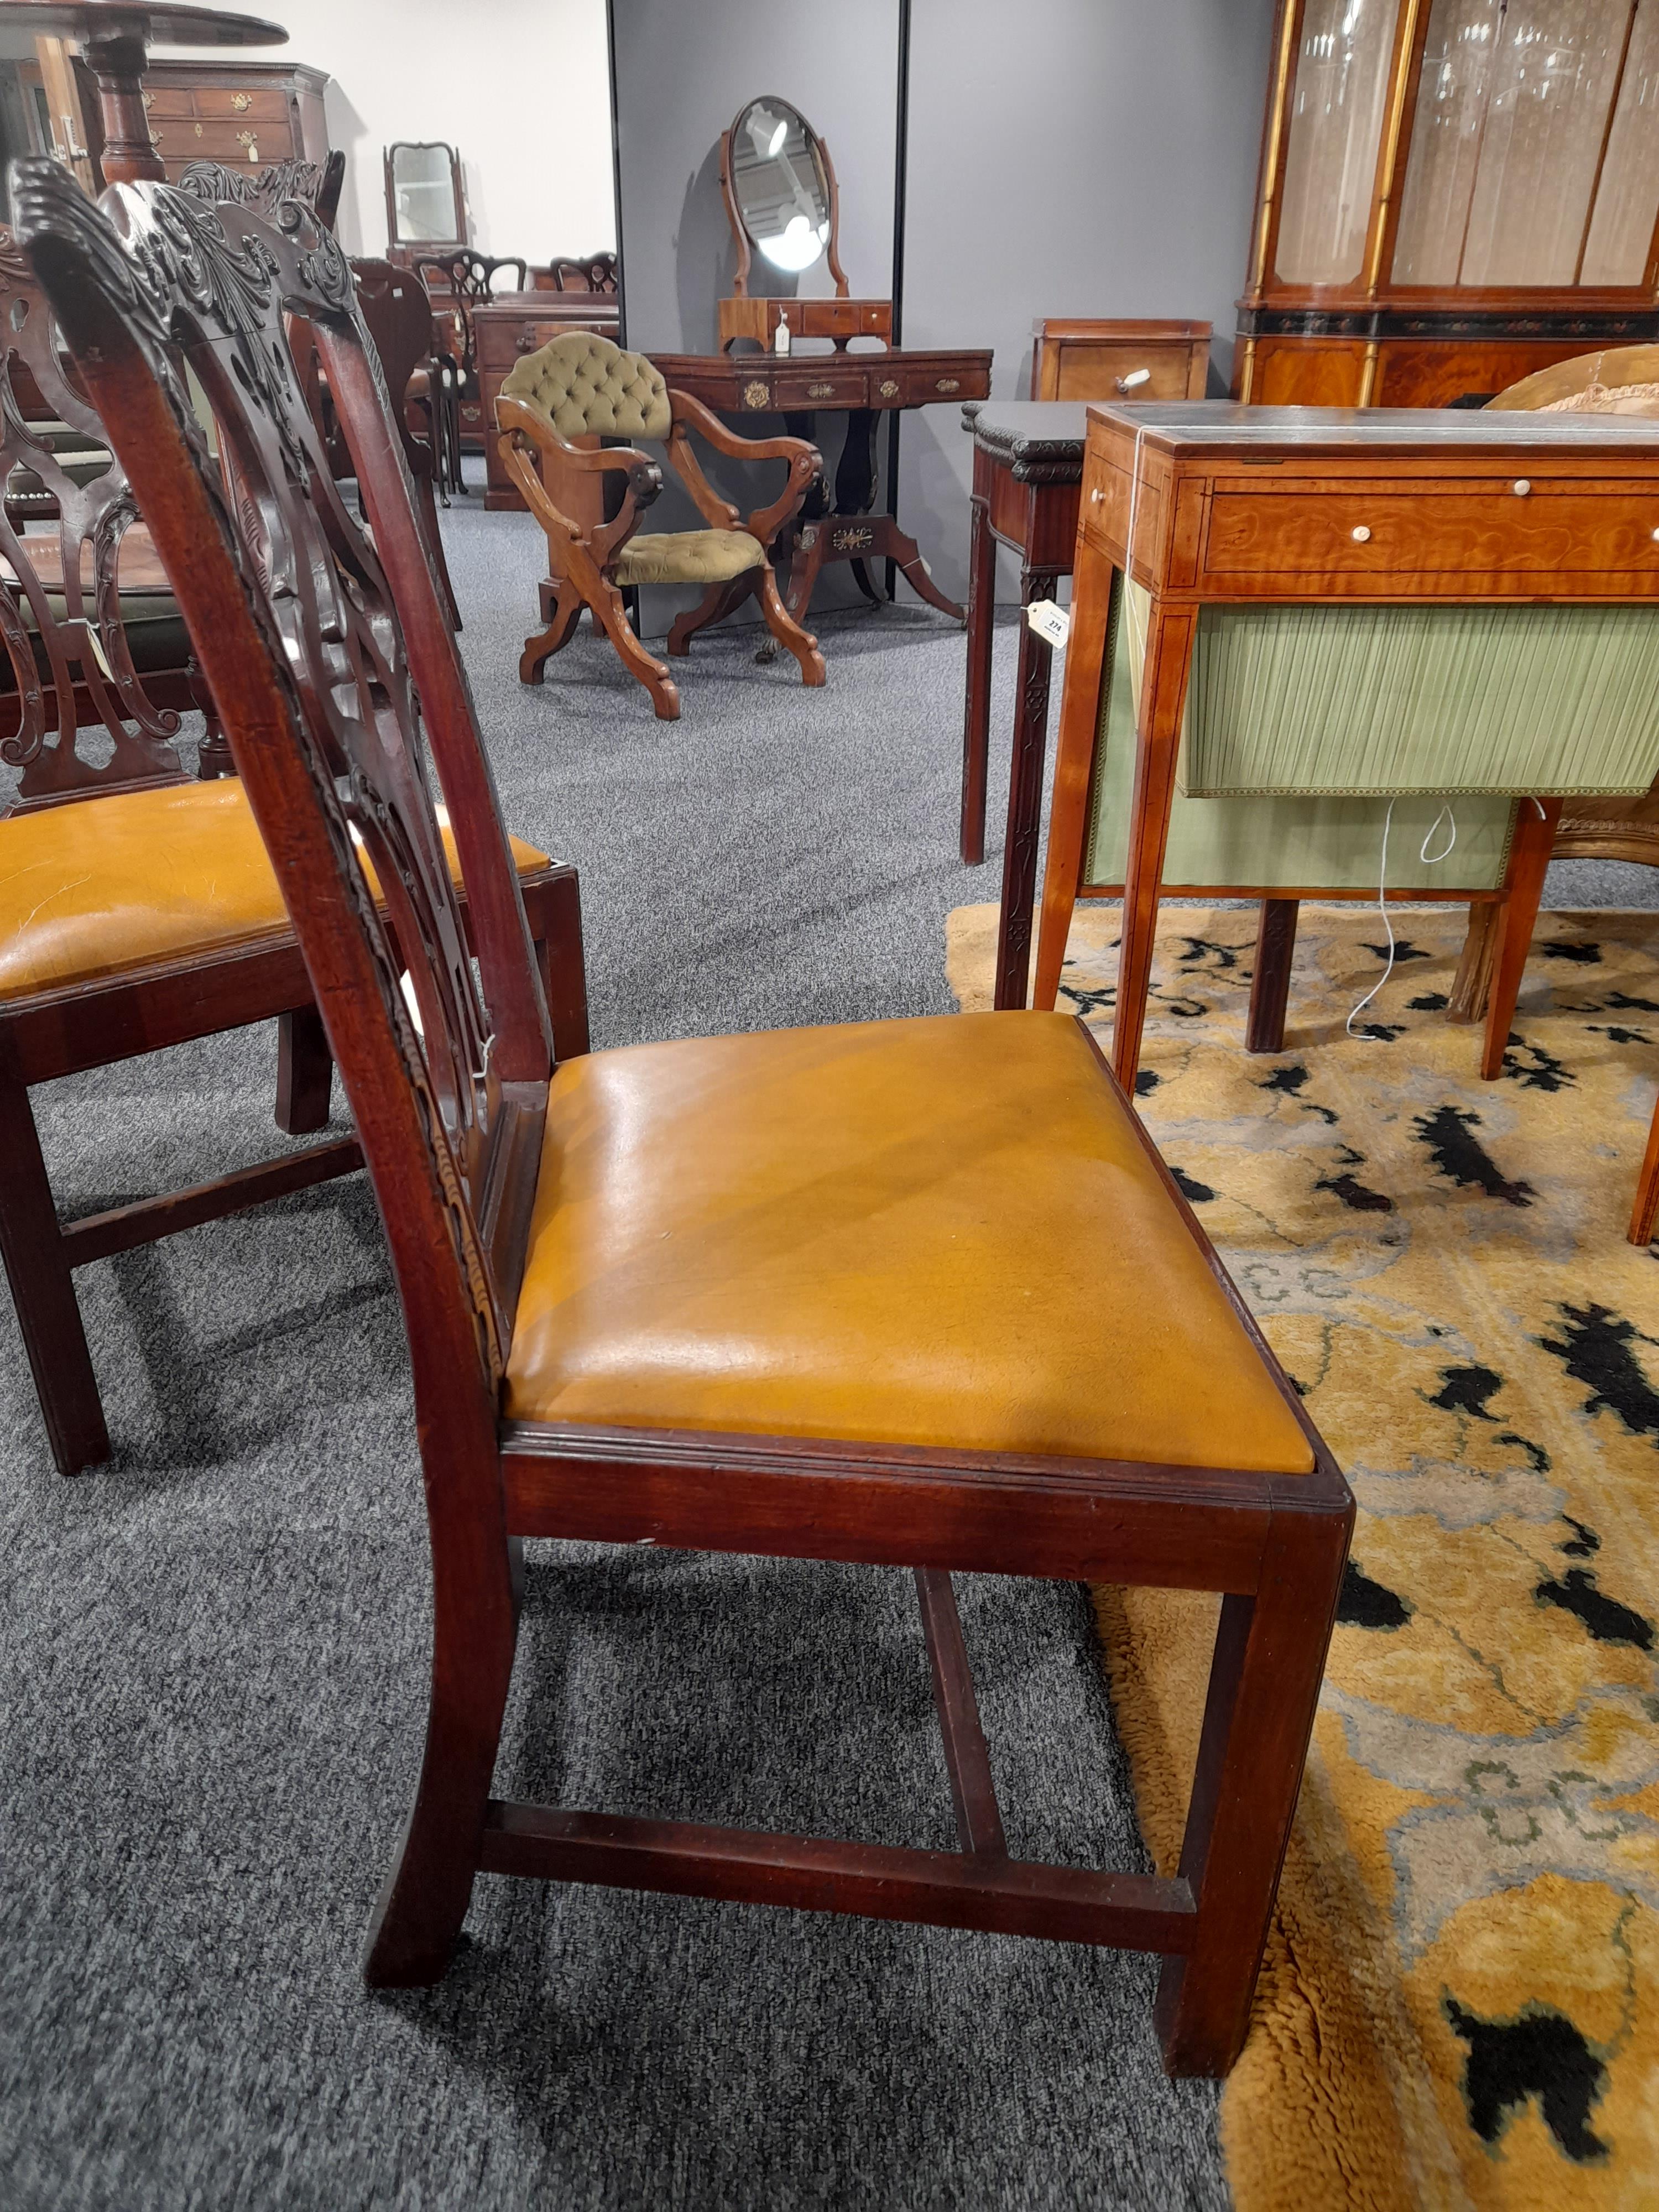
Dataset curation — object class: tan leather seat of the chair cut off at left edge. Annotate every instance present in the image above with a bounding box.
[0,776,560,1000]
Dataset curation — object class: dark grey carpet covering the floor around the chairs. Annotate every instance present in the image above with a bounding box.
[0,502,1225,2212]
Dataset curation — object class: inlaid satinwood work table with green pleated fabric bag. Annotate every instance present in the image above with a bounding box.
[1033,400,1659,1091]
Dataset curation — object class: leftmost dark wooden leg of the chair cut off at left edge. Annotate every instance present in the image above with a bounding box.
[0,1048,111,1475]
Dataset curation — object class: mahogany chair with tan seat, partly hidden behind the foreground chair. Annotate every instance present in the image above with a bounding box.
[0,175,586,1473]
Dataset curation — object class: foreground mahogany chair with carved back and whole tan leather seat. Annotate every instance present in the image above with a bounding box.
[13,161,1354,2073]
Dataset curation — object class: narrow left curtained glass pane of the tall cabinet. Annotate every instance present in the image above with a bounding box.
[1274,0,1398,283]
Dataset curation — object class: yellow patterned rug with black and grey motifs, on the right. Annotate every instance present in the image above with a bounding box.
[949,907,1659,2212]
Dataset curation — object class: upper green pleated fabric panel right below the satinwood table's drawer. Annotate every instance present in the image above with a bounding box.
[1121,584,1659,799]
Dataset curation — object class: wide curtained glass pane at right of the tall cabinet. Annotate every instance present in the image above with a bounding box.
[1394,0,1639,285]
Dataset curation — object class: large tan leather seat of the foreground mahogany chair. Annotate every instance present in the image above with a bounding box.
[504,1013,1312,1473]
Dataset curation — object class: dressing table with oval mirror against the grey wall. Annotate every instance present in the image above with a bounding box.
[650,95,991,622]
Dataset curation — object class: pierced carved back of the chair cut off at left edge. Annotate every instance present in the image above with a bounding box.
[0,232,188,814]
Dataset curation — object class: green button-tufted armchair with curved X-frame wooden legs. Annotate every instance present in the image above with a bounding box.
[495,330,823,721]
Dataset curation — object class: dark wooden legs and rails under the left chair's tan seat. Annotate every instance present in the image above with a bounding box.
[0,865,588,1475]
